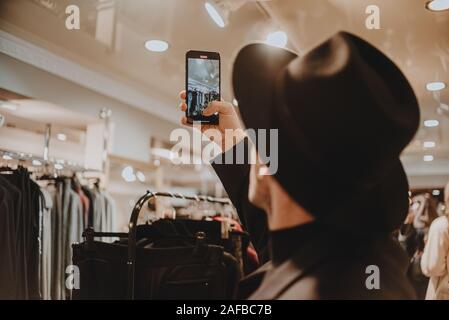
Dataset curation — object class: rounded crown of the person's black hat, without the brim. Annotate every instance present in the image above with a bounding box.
[278,32,419,184]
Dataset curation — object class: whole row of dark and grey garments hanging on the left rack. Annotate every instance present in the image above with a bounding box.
[0,167,115,300]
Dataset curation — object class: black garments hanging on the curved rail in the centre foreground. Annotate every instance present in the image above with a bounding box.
[73,219,249,299]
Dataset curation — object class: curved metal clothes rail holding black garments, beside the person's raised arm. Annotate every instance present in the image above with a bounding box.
[127,191,232,300]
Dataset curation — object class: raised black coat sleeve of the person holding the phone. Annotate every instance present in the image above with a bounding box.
[212,138,270,264]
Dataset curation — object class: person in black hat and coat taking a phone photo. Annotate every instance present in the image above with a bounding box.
[181,32,420,299]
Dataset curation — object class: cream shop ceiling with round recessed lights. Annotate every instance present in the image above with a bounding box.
[0,0,449,178]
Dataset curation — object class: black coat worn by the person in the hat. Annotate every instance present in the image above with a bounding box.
[213,141,415,300]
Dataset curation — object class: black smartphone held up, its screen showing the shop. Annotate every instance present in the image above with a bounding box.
[186,50,221,124]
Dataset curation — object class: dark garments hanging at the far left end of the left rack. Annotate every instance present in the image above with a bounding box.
[0,167,41,299]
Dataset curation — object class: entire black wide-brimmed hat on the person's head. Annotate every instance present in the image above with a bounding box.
[233,32,420,233]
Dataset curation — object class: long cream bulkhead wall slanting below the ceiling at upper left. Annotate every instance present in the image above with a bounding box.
[0,53,176,161]
